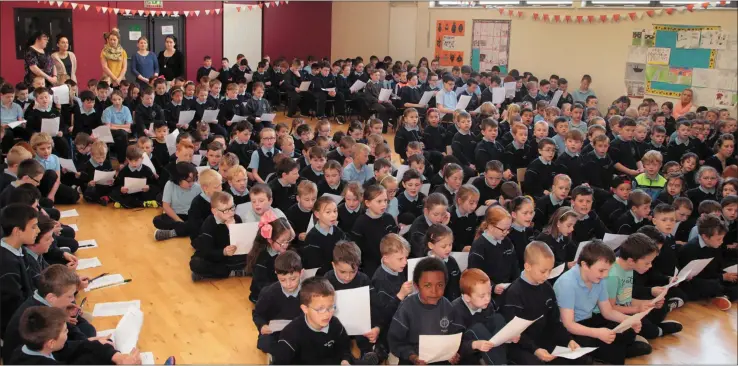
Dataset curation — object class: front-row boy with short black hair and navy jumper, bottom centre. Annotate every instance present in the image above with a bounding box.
[387,258,471,364]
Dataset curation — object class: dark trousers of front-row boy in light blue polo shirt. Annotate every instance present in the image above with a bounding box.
[572,314,636,365]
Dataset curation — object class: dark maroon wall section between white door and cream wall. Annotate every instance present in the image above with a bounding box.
[262,1,333,60]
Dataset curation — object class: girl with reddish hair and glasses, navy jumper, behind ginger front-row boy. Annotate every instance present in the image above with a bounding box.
[469,206,520,303]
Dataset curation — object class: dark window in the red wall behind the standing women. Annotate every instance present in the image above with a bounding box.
[13,8,74,60]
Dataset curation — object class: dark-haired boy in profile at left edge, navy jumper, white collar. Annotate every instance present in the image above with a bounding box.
[0,203,38,336]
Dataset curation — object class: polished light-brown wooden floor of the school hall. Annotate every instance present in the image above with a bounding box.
[59,113,738,365]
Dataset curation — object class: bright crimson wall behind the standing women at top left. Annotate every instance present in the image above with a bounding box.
[0,1,223,84]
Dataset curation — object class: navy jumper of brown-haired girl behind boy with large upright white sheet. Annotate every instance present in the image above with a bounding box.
[351,211,399,275]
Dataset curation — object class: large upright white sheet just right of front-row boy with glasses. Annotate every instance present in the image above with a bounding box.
[333,286,372,336]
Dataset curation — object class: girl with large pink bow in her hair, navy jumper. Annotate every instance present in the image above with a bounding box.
[246,214,295,303]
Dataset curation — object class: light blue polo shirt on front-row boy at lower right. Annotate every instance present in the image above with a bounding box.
[554,264,609,322]
